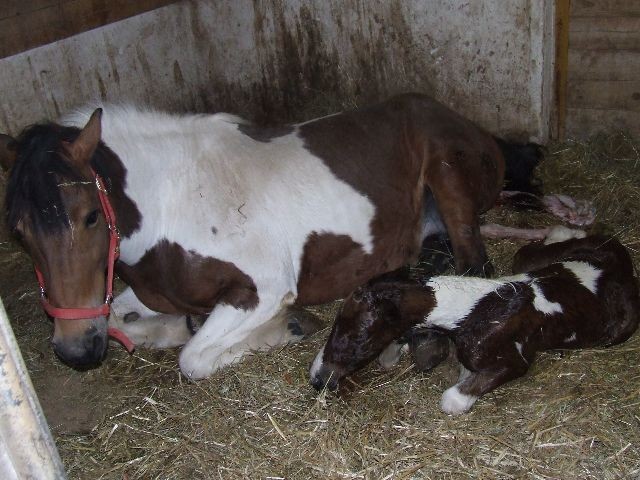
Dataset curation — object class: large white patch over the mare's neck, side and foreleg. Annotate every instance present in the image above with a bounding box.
[67,106,375,378]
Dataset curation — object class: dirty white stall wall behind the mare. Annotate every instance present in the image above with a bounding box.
[0,0,553,140]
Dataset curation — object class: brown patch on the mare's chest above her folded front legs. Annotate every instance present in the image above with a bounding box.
[116,240,259,314]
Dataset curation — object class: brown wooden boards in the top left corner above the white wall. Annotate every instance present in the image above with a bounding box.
[0,0,176,58]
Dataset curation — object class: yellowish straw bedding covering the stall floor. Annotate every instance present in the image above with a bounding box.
[0,129,640,480]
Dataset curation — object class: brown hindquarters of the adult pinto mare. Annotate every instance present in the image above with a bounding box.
[298,94,505,282]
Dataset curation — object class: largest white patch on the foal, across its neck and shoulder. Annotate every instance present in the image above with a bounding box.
[420,274,529,329]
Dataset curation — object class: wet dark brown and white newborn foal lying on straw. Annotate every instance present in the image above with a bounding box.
[310,231,640,415]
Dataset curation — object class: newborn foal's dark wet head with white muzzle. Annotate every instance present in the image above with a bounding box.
[310,280,422,390]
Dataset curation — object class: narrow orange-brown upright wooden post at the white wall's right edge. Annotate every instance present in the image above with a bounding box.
[555,0,571,140]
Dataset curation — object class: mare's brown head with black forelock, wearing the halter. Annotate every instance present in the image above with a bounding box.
[0,110,115,367]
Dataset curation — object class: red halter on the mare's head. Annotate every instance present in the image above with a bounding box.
[34,170,134,353]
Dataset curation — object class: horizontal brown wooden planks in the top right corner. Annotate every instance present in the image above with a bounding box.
[566,0,640,138]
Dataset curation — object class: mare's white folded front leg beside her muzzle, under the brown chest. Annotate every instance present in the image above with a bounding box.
[109,287,193,348]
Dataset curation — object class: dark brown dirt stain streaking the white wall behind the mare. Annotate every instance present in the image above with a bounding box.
[192,0,435,123]
